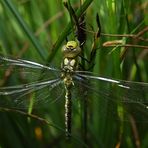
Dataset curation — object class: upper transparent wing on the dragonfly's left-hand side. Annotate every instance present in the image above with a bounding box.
[0,56,60,85]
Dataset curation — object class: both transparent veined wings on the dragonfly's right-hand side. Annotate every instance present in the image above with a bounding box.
[74,72,148,122]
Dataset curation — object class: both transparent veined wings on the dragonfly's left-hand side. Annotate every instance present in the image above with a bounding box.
[0,56,64,108]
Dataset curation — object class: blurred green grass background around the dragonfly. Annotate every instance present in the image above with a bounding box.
[0,0,148,148]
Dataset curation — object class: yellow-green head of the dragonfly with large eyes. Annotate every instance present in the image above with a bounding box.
[62,41,81,59]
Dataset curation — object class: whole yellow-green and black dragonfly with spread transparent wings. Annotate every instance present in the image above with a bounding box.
[0,41,148,138]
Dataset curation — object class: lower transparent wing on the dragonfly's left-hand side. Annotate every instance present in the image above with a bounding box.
[0,79,63,109]
